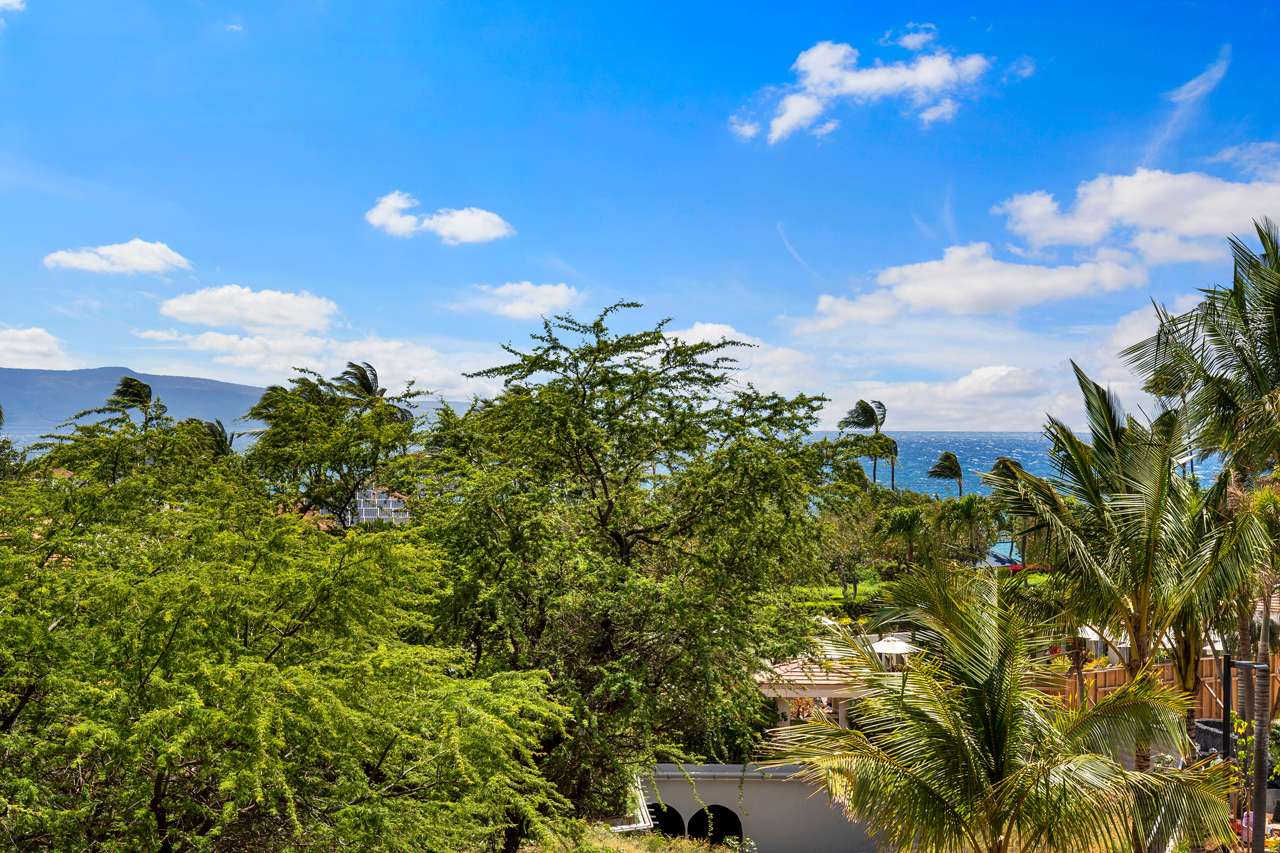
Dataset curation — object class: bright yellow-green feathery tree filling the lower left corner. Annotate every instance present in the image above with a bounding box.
[0,435,566,853]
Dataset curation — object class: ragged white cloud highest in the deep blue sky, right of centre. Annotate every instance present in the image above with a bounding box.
[769,36,991,143]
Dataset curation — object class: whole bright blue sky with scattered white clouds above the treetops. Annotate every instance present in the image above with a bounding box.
[0,0,1280,429]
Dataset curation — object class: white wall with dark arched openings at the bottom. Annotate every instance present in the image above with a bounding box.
[644,765,879,853]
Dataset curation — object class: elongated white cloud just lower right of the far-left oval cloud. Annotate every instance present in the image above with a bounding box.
[160,284,338,332]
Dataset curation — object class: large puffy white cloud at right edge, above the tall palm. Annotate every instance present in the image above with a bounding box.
[992,168,1280,264]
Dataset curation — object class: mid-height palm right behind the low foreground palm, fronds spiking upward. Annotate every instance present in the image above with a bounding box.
[983,365,1239,768]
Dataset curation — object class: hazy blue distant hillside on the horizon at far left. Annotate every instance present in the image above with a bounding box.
[0,368,262,433]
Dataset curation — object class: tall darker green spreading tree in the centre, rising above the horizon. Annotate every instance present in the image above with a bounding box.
[413,305,829,816]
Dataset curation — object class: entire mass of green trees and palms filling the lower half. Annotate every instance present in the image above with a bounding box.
[0,220,1280,853]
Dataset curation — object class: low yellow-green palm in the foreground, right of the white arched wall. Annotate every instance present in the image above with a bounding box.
[768,558,1231,853]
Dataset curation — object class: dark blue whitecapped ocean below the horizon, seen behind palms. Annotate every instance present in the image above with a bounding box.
[815,432,1221,497]
